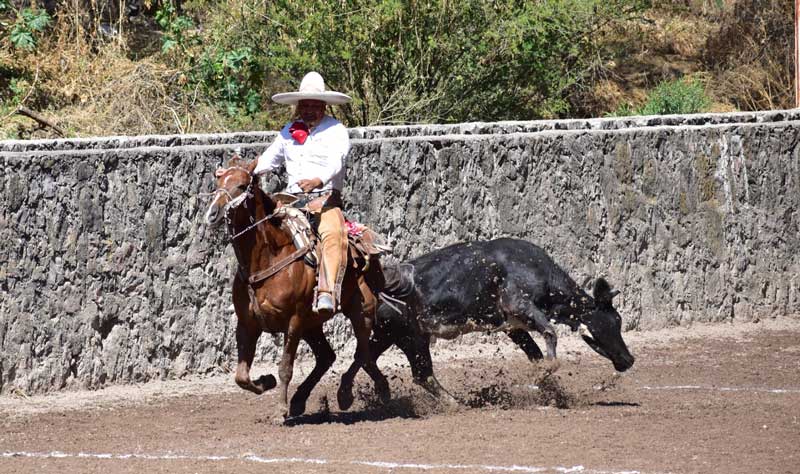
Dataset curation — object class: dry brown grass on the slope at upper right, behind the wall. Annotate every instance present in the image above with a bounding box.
[579,0,794,116]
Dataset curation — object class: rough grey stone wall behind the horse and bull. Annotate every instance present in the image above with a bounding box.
[0,111,800,393]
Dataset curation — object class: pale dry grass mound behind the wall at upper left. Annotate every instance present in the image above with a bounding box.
[0,12,229,138]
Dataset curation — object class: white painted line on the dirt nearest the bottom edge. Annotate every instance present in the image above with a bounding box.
[0,451,642,474]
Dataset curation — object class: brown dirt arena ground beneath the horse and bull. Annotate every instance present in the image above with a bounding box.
[0,319,800,474]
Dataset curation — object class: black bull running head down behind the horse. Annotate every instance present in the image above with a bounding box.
[350,238,634,393]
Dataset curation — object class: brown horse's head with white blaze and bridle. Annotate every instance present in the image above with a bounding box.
[205,155,257,225]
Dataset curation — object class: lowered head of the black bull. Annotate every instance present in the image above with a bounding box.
[578,278,634,372]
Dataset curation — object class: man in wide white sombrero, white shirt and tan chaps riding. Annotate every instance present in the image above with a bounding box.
[254,72,350,312]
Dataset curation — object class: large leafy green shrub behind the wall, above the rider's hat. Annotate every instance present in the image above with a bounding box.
[169,0,648,125]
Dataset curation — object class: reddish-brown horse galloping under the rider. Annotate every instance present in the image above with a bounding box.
[205,156,389,421]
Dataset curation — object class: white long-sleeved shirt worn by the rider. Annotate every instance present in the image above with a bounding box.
[254,115,350,192]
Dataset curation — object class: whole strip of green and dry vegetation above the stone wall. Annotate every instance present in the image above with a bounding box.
[0,0,793,137]
